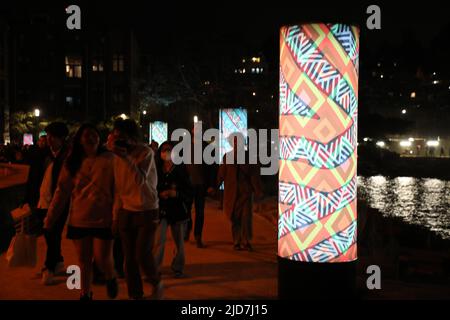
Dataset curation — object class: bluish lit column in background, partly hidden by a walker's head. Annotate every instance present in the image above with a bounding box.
[219,108,247,161]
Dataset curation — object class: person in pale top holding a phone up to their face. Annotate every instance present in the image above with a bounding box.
[107,119,163,299]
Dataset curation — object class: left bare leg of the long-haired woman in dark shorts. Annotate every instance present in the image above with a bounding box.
[73,237,93,296]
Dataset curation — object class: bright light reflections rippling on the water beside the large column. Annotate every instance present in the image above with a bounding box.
[358,176,450,238]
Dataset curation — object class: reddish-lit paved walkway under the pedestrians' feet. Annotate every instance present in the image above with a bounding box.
[0,201,277,300]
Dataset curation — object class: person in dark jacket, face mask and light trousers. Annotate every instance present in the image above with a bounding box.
[155,142,192,278]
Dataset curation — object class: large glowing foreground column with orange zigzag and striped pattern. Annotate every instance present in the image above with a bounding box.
[278,24,359,263]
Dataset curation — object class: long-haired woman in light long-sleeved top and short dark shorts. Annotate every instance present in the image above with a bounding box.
[45,124,118,300]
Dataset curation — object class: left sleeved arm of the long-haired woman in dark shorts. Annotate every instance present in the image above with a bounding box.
[44,165,74,229]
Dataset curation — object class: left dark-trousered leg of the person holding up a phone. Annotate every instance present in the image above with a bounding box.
[119,212,144,299]
